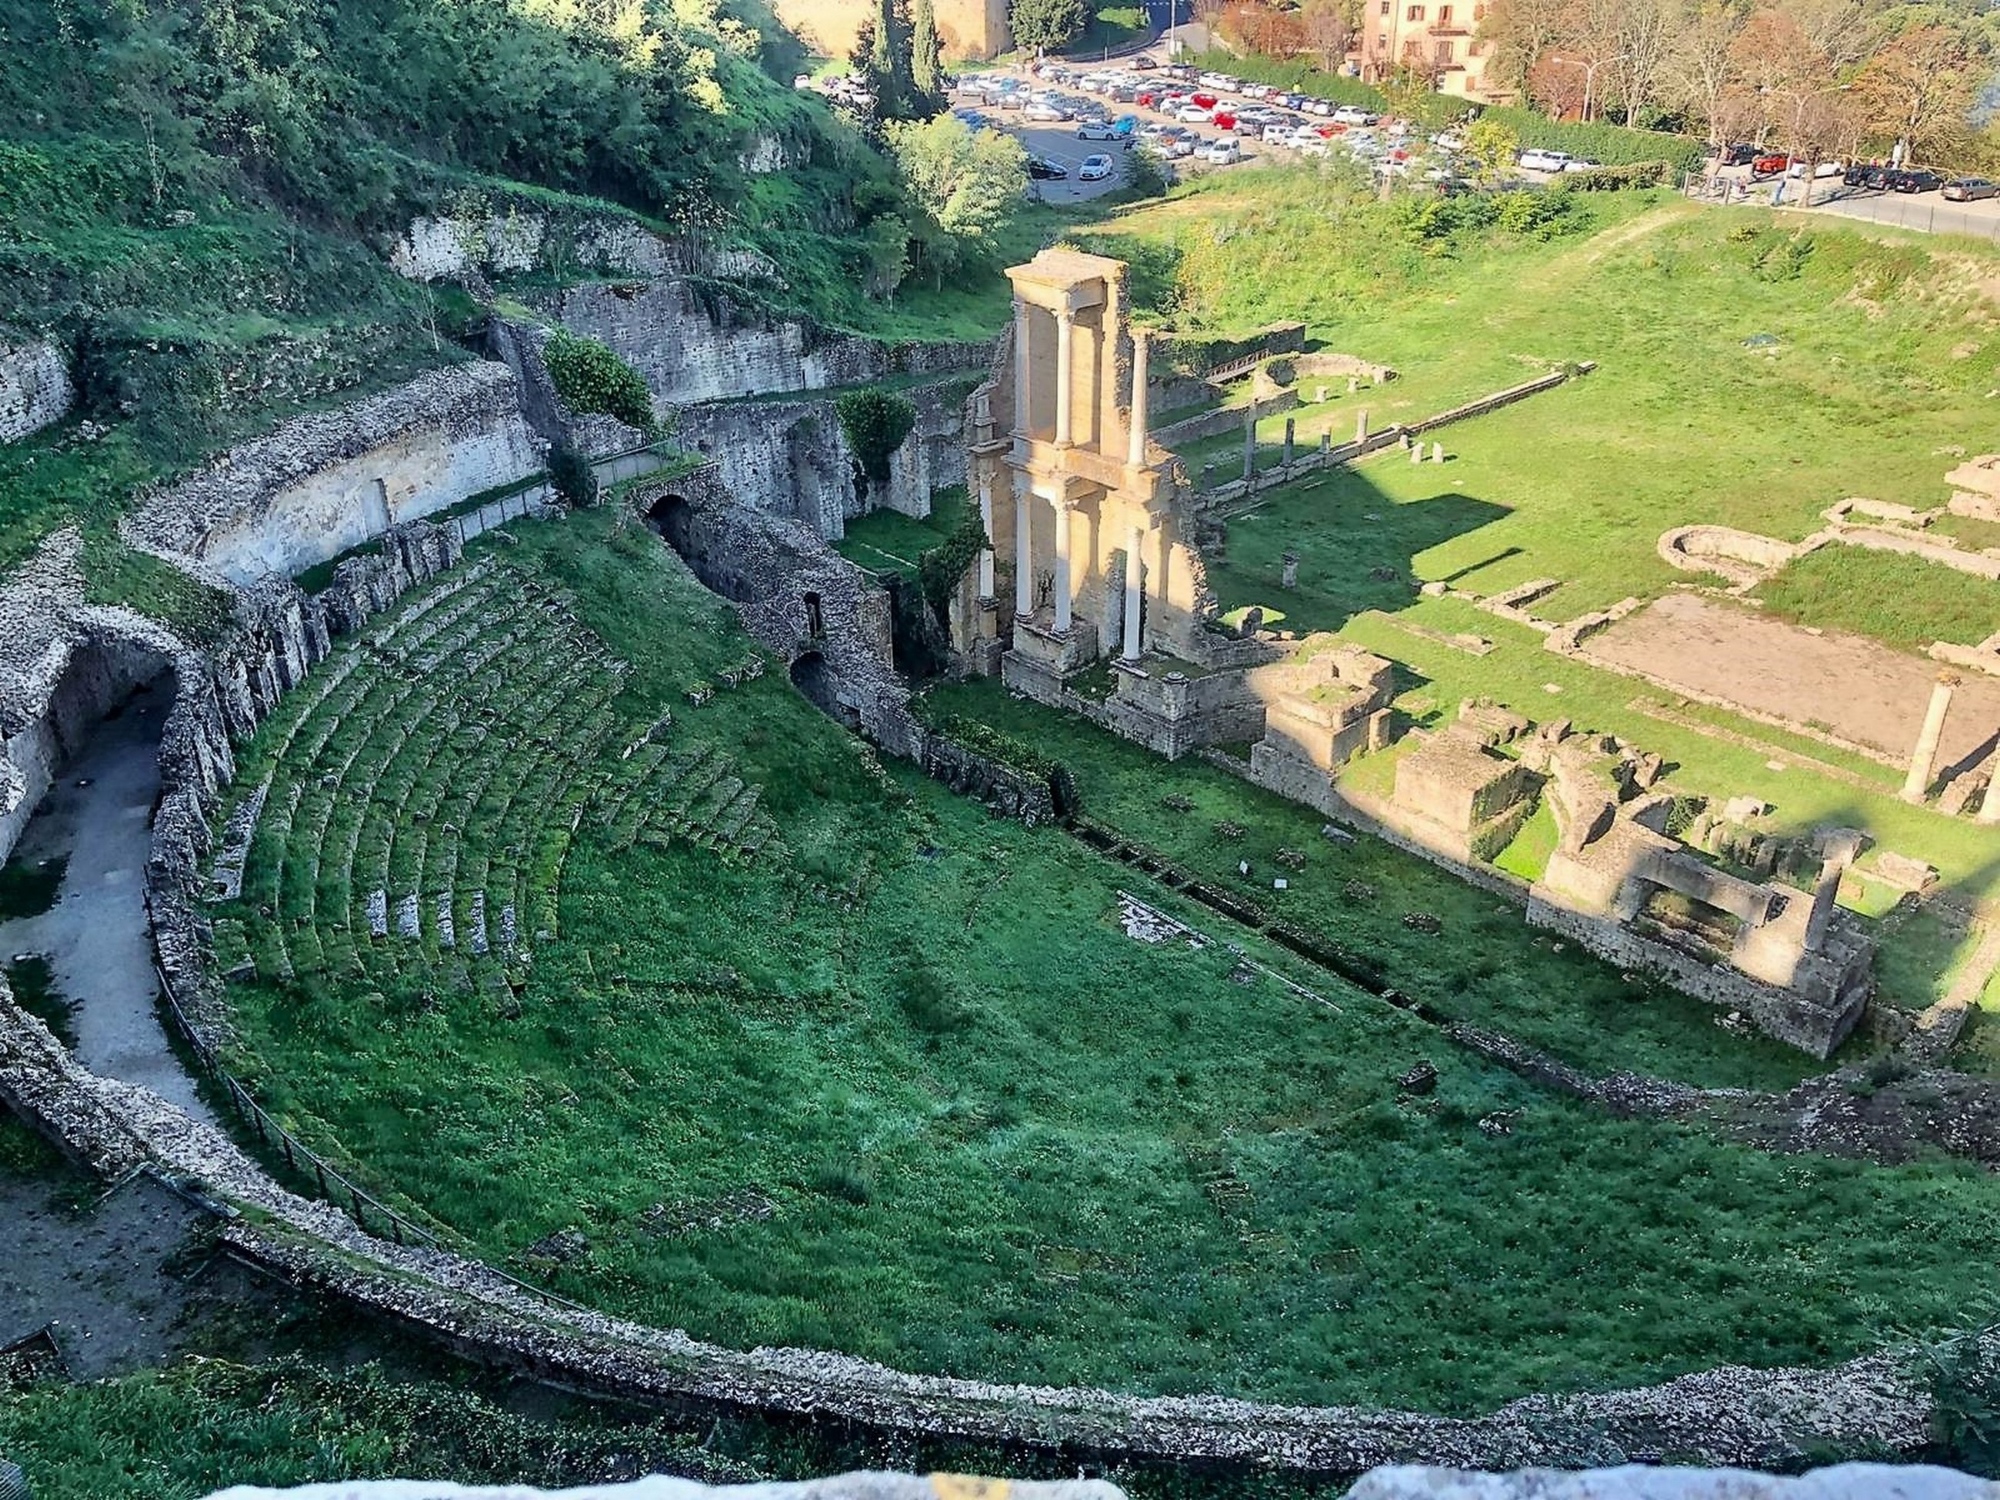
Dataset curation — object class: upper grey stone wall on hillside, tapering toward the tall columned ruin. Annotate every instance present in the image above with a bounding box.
[540,278,992,410]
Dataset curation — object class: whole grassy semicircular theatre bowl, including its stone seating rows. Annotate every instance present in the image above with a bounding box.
[199,510,2000,1410]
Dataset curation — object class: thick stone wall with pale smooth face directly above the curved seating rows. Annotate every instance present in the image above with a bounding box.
[122,360,544,584]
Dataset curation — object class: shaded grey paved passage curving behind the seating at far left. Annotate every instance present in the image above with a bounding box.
[0,686,214,1122]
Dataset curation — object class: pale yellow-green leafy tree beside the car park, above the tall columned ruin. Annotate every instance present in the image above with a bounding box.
[888,114,1028,288]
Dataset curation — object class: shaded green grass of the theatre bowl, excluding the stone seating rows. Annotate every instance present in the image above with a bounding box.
[215,516,2000,1410]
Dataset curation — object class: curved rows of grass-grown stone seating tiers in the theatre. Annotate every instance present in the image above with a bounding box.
[203,558,782,984]
